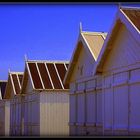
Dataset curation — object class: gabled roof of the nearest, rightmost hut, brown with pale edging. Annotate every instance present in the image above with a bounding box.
[93,7,140,75]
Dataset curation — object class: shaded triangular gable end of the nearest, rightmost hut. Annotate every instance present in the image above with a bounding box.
[93,6,140,75]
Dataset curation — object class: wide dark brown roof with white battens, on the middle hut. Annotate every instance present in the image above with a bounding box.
[23,60,69,90]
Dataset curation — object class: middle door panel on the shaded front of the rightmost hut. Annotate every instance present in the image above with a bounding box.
[113,72,128,133]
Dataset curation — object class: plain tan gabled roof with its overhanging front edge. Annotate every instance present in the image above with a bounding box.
[63,31,107,84]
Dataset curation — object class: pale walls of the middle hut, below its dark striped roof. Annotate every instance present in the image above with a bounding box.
[23,74,69,136]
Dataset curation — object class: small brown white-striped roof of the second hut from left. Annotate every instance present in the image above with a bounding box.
[4,72,23,99]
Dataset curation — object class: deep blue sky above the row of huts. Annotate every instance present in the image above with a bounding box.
[0,4,139,80]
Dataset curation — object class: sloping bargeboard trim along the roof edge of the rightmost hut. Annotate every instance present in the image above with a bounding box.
[93,7,140,75]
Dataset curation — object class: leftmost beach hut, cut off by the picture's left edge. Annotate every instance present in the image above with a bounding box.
[0,80,10,136]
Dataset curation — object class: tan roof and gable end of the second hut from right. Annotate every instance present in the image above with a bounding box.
[63,32,105,84]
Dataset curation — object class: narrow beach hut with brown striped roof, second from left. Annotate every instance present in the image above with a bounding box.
[4,71,23,136]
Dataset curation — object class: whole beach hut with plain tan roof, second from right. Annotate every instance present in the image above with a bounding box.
[63,27,107,135]
